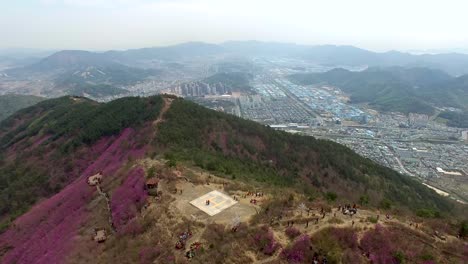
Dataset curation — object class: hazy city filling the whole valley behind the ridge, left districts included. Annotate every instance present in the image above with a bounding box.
[0,53,468,203]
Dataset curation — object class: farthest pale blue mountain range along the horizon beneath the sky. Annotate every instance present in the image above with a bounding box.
[6,41,468,76]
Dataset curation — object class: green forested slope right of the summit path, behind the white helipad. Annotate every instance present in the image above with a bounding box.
[156,99,451,211]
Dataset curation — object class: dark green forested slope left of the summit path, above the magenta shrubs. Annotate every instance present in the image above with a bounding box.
[0,97,162,224]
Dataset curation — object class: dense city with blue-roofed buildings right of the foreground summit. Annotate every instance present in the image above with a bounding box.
[161,60,468,203]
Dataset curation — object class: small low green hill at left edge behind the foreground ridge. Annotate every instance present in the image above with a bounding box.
[0,94,45,121]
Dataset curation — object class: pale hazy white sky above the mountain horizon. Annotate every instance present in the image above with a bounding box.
[0,0,468,51]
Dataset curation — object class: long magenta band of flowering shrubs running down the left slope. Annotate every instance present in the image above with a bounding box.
[0,129,145,264]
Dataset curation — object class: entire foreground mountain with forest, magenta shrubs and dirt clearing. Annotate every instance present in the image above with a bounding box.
[0,96,468,263]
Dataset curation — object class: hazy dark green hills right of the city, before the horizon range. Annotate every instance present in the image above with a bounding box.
[290,67,468,114]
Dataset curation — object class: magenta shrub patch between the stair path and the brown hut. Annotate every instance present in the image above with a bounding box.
[111,167,148,233]
